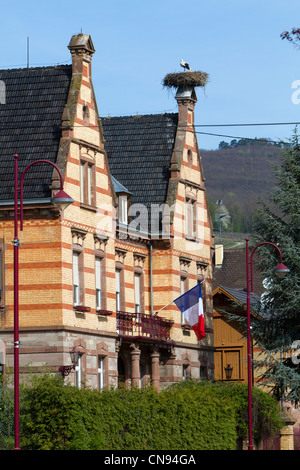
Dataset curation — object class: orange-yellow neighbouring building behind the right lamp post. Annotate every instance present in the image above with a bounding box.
[213,244,264,383]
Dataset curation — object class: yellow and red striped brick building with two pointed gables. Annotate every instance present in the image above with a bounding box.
[0,34,214,389]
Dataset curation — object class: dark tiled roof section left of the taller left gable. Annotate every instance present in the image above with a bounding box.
[0,65,72,200]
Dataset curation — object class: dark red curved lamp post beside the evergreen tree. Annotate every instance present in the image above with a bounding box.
[246,238,290,450]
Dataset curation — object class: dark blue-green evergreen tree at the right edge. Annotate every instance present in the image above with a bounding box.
[252,131,300,402]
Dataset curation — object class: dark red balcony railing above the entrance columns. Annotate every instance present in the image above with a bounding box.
[117,312,174,342]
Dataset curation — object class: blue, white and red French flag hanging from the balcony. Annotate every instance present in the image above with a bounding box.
[174,284,205,341]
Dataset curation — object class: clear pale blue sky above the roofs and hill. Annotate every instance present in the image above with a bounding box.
[0,0,300,149]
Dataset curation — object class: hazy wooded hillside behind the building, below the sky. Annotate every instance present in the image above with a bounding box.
[200,142,280,232]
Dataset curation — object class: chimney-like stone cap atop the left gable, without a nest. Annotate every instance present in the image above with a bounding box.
[68,33,95,78]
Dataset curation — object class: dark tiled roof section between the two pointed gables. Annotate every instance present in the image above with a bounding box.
[101,113,178,209]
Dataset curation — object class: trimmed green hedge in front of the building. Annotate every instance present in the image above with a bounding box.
[21,376,278,450]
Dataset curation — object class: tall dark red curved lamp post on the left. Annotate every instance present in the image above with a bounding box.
[12,155,73,450]
